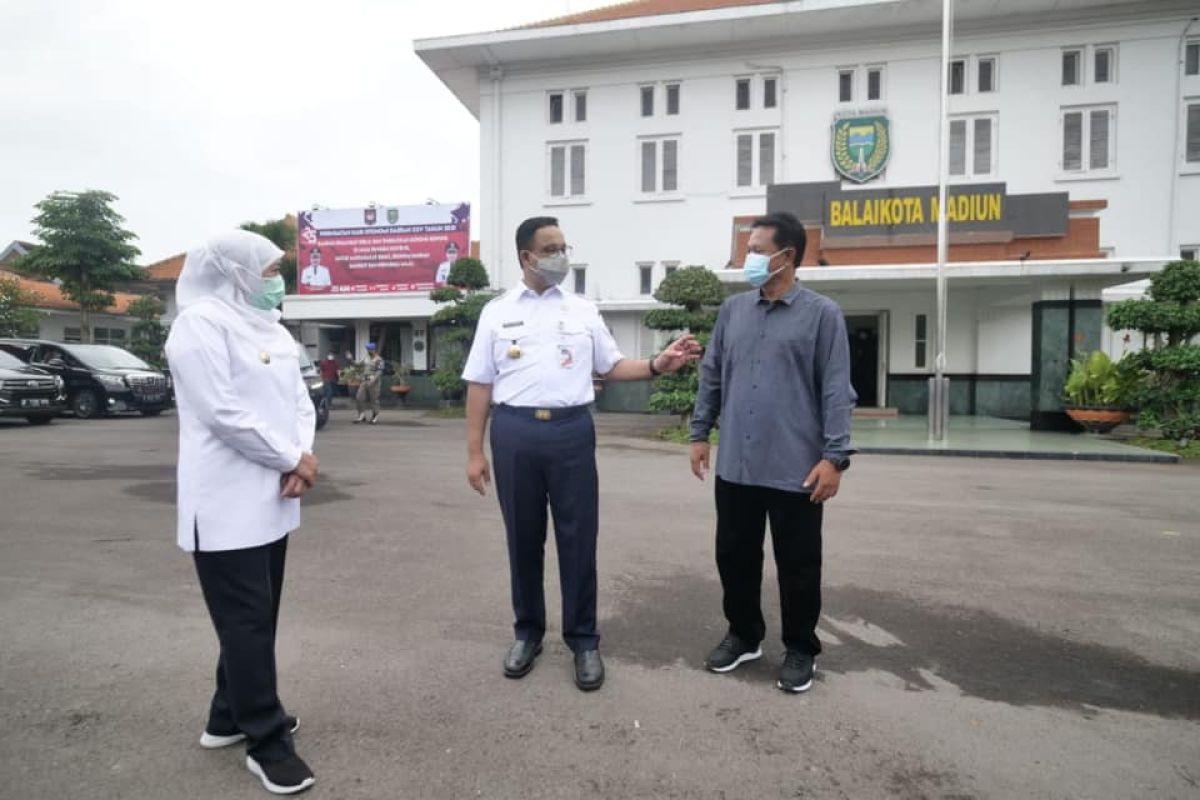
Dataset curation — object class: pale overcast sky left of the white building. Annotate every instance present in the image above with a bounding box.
[0,0,613,264]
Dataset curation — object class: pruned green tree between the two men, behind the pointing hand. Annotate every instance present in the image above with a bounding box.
[644,266,725,423]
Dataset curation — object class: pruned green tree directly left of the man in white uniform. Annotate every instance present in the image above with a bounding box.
[430,258,496,401]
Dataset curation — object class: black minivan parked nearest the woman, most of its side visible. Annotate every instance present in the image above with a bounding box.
[0,339,172,420]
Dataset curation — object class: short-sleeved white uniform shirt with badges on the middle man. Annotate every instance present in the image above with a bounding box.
[462,284,624,408]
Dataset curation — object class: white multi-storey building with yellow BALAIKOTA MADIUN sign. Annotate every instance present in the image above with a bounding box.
[416,0,1200,427]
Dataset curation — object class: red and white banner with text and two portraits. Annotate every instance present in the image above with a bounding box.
[296,203,470,294]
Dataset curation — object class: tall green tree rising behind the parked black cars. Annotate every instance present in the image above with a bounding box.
[19,191,145,342]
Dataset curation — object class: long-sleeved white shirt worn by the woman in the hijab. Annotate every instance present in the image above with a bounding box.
[167,302,316,552]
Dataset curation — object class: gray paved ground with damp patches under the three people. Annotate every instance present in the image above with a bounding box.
[0,413,1200,800]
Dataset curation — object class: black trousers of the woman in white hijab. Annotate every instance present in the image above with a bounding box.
[193,536,294,760]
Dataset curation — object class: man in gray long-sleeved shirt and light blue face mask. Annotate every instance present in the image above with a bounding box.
[691,213,857,692]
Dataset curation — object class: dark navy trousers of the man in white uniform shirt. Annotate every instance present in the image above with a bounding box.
[491,405,600,652]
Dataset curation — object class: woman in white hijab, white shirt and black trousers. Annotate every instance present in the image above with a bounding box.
[167,230,317,794]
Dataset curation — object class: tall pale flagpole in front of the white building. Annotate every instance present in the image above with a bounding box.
[929,0,954,441]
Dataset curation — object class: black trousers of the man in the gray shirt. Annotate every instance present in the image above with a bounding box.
[716,477,823,655]
